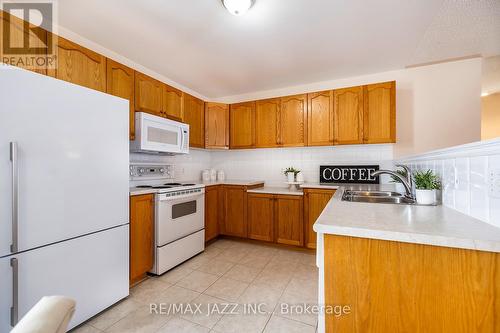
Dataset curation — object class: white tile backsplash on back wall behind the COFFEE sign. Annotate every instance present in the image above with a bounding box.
[211,144,393,187]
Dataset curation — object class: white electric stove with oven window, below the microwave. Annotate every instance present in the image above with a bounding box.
[130,164,205,275]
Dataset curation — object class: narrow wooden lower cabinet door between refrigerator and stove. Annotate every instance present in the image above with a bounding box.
[130,194,154,284]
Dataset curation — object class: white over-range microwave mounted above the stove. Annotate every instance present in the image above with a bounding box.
[130,112,189,155]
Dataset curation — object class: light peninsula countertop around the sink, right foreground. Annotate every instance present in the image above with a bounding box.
[314,185,500,253]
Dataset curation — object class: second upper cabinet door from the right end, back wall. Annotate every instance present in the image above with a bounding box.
[333,87,363,145]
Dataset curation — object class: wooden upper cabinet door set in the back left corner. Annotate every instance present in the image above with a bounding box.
[205,103,229,149]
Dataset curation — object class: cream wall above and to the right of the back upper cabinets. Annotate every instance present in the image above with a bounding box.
[219,58,482,157]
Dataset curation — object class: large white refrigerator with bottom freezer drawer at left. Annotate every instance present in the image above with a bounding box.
[0,65,129,332]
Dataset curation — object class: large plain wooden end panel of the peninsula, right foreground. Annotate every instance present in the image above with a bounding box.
[324,235,500,333]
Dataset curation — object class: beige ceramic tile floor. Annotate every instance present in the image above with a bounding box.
[72,239,318,333]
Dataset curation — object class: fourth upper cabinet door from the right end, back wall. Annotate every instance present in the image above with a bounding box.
[278,94,307,147]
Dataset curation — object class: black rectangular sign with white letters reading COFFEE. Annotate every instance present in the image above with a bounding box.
[319,165,380,184]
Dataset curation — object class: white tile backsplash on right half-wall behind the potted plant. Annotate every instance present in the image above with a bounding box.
[399,141,500,227]
